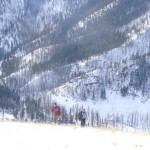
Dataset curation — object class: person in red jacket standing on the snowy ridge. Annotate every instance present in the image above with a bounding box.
[51,103,60,123]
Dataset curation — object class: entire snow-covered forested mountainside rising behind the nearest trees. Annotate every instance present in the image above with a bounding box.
[0,0,150,124]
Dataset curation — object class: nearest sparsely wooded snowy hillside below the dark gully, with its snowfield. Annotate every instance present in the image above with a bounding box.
[2,28,150,124]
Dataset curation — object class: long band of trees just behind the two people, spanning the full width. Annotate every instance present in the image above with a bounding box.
[0,85,150,130]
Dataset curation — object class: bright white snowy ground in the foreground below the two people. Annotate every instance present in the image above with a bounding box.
[0,122,150,150]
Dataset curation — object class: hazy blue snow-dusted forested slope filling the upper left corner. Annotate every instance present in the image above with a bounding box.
[0,0,87,53]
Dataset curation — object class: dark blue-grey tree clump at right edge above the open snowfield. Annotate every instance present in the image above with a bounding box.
[120,55,150,101]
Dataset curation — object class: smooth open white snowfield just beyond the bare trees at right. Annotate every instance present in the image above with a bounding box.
[51,91,150,116]
